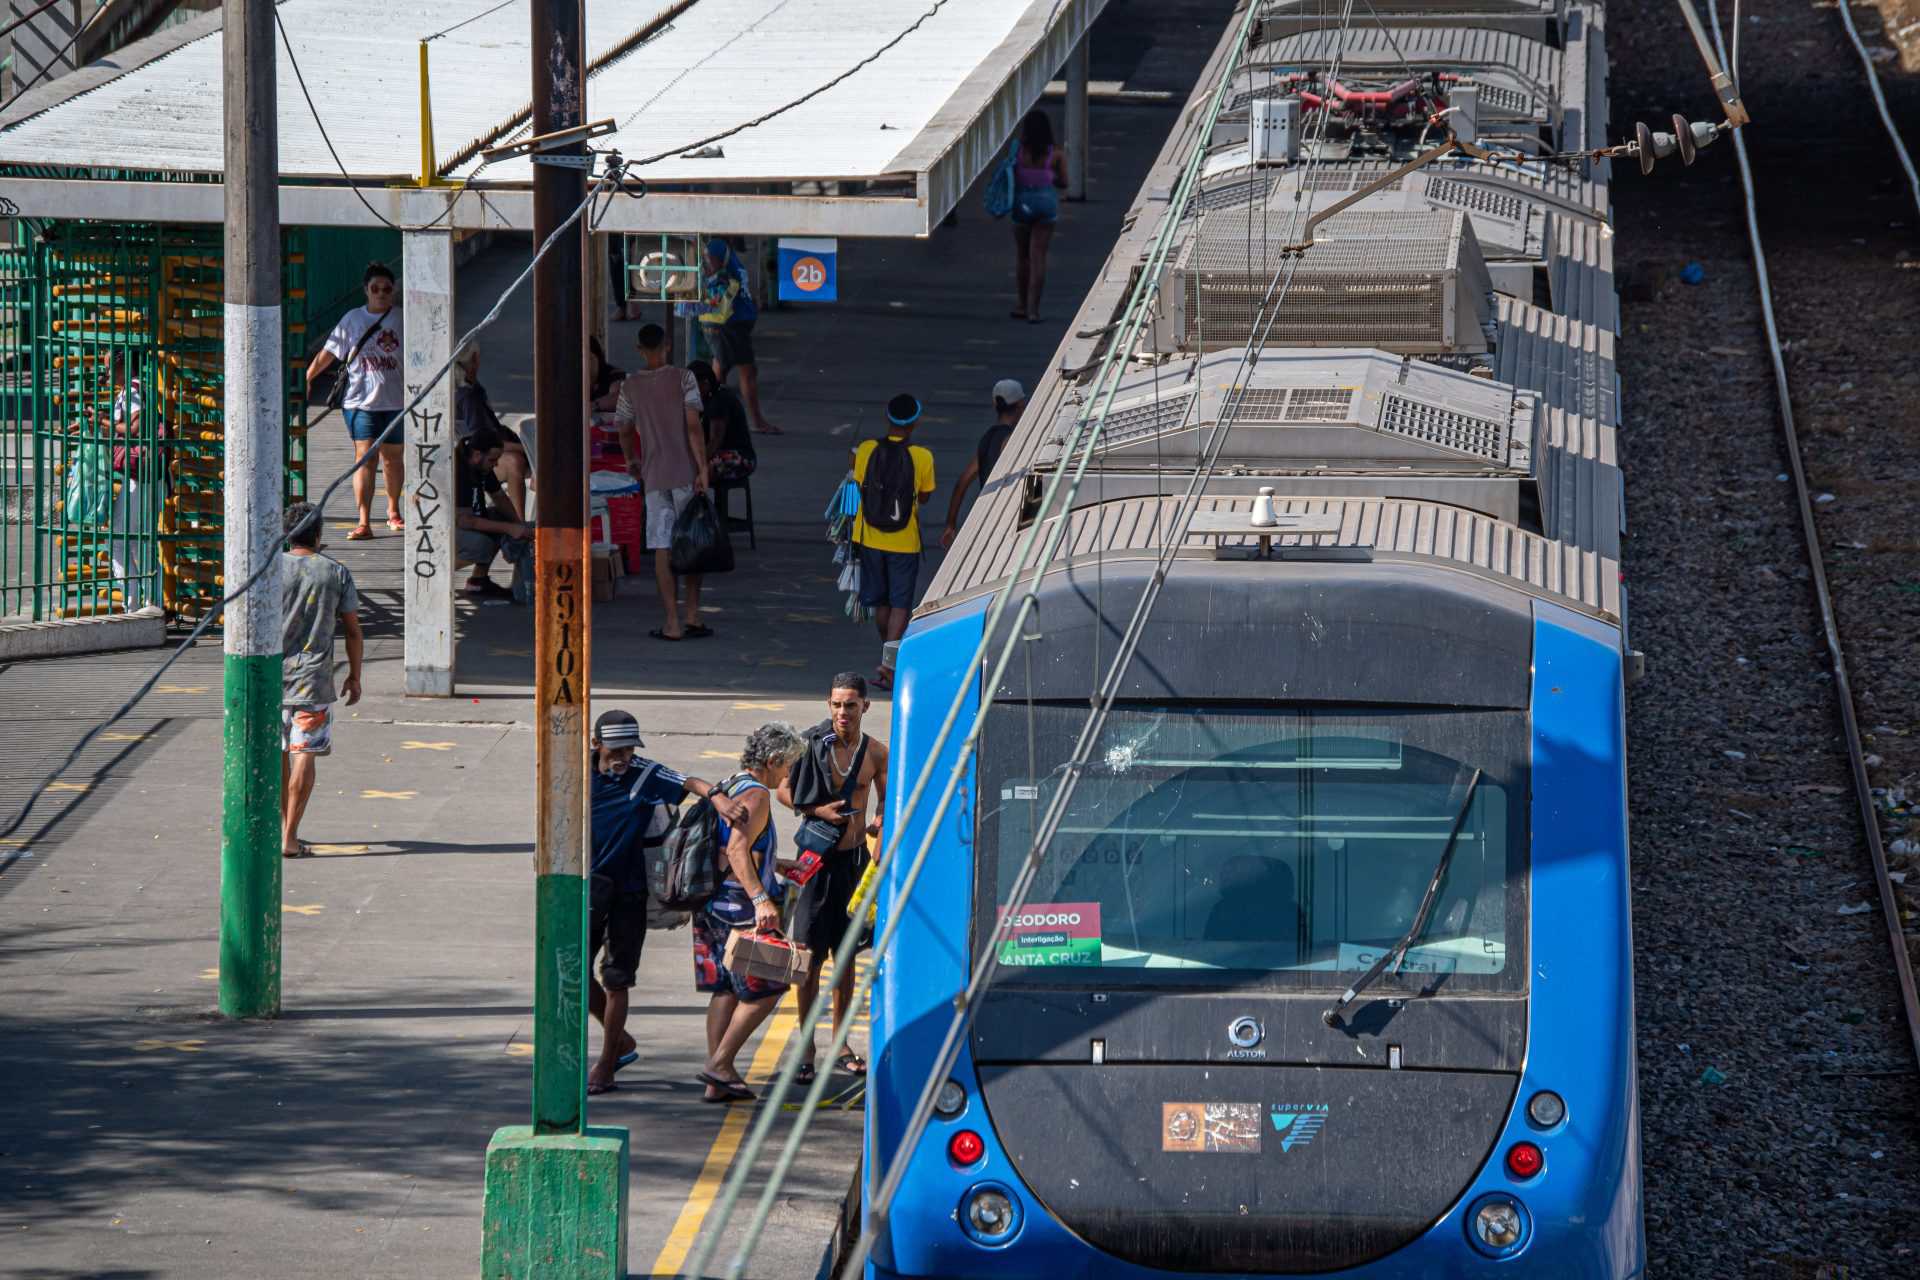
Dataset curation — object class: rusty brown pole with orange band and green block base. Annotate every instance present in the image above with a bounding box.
[480,0,628,1280]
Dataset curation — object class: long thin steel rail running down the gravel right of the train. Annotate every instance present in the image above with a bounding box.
[1707,0,1920,1063]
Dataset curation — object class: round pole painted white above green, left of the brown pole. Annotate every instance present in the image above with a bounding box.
[221,0,286,1017]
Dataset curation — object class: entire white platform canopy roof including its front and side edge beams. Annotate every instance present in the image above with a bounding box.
[0,0,1106,236]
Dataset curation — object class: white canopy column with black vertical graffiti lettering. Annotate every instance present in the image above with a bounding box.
[401,230,459,699]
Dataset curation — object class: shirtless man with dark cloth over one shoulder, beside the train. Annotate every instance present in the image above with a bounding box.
[780,672,887,1084]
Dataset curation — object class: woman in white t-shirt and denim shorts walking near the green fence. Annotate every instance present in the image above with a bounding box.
[307,263,407,541]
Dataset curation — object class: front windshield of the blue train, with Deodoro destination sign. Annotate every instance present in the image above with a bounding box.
[973,702,1526,994]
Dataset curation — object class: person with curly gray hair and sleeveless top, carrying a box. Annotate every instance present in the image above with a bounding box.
[693,720,806,1102]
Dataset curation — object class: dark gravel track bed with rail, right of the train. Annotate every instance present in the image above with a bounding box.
[1613,0,1920,1278]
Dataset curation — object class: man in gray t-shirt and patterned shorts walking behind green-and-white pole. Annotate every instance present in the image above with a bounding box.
[280,503,363,858]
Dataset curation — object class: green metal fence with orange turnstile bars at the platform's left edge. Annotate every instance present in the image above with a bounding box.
[0,223,399,620]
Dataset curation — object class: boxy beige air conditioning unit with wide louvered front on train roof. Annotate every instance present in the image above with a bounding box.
[1152,207,1494,355]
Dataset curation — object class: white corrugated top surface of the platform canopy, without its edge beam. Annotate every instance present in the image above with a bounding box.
[0,0,1098,182]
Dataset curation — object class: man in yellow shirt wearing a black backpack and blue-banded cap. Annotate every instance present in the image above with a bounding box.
[852,395,933,689]
